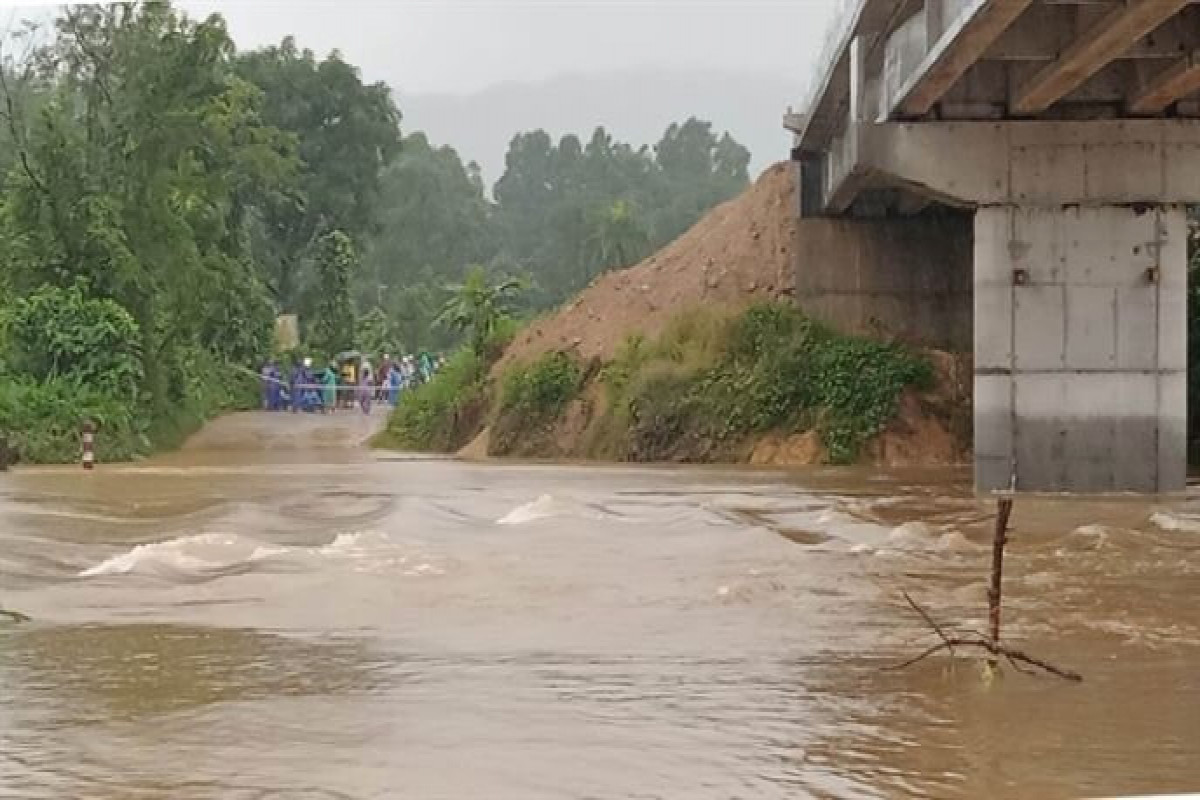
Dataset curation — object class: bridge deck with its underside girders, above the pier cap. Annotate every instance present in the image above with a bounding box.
[786,0,1200,154]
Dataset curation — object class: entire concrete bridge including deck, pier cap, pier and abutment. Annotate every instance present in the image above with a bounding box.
[785,0,1200,492]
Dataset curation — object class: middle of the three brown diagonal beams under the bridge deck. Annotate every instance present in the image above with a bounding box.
[1010,0,1188,115]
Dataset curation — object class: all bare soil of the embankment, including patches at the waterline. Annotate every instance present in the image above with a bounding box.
[460,163,971,465]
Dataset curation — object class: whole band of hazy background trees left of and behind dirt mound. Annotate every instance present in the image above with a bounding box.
[355,119,750,331]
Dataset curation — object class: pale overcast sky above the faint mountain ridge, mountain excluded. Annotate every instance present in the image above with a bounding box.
[0,0,839,94]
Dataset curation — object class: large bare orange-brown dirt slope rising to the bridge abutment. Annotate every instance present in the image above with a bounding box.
[497,162,796,369]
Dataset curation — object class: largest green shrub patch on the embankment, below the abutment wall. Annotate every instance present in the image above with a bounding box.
[592,303,931,463]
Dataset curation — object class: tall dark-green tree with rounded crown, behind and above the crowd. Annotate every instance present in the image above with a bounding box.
[236,36,401,309]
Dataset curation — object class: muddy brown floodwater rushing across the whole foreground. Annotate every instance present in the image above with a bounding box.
[0,414,1200,800]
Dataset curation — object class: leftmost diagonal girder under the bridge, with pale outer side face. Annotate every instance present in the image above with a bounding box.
[889,0,1033,116]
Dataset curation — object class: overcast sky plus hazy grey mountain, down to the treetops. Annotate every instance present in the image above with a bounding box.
[0,0,850,180]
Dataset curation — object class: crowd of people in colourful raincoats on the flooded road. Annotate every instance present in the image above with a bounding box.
[259,353,444,414]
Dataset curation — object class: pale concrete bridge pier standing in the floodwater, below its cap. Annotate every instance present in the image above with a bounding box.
[974,205,1187,492]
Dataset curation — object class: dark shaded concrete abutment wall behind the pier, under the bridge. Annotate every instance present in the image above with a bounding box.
[794,210,972,353]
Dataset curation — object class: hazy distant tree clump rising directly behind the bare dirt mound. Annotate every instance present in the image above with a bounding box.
[494,119,750,302]
